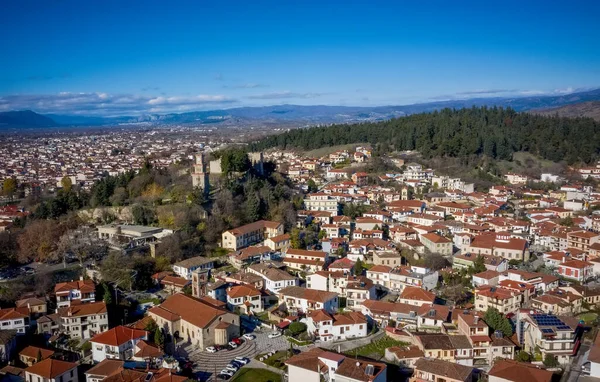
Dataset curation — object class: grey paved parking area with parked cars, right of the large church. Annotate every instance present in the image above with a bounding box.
[179,330,290,381]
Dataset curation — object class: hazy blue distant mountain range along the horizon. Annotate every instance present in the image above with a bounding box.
[0,89,600,129]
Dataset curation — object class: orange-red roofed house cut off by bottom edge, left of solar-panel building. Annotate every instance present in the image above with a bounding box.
[488,359,554,382]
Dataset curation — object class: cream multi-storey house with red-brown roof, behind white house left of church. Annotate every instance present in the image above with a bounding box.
[59,302,108,339]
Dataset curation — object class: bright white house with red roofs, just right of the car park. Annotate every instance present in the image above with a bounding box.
[306,310,368,342]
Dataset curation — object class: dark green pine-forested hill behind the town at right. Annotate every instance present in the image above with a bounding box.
[251,107,600,164]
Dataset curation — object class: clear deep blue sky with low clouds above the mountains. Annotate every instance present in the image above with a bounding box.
[0,0,600,115]
